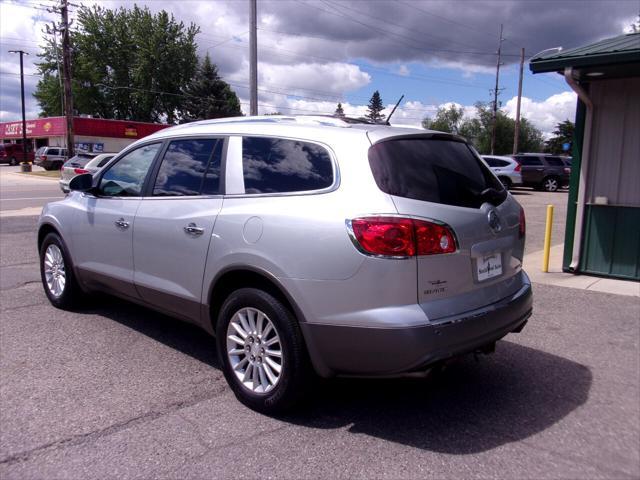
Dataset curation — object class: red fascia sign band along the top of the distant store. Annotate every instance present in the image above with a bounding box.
[0,117,166,139]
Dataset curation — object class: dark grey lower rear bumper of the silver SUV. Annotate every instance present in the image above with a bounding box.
[301,283,532,376]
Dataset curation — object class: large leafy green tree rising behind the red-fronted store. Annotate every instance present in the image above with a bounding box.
[34,5,199,123]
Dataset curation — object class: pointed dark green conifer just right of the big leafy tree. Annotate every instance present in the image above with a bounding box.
[180,53,242,122]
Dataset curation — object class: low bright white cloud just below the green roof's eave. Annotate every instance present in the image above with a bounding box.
[504,92,576,137]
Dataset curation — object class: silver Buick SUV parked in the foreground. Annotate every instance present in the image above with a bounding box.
[38,116,532,412]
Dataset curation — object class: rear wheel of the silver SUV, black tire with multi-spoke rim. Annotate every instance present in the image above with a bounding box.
[216,288,313,415]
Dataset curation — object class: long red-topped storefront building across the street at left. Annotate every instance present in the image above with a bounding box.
[0,117,170,153]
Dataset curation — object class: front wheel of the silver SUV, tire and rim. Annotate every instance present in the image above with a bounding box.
[40,232,81,310]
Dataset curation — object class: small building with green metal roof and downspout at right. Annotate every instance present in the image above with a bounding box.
[529,33,640,280]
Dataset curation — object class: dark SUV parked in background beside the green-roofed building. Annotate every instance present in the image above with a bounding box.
[513,153,571,192]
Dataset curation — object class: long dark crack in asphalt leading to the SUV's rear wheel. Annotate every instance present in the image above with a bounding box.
[0,385,227,466]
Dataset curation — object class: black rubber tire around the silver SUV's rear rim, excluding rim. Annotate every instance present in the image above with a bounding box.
[216,288,305,414]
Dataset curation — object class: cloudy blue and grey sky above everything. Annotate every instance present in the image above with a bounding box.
[0,0,640,134]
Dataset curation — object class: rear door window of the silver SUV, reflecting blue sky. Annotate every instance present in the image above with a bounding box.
[153,138,223,196]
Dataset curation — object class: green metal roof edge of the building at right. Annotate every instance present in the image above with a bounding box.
[529,33,640,73]
